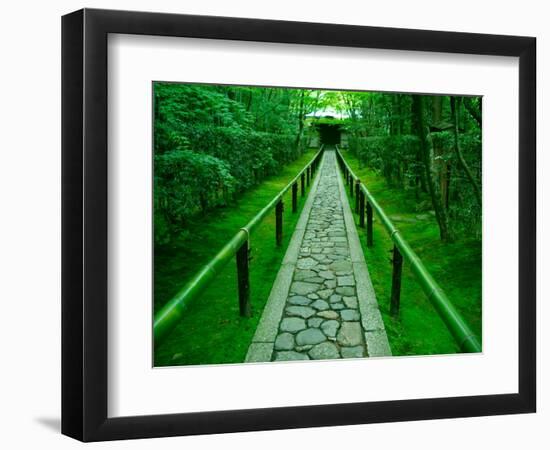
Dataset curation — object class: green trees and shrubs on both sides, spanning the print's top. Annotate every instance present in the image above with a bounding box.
[154,83,481,243]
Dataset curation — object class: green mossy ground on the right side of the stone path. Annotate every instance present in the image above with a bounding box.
[344,152,481,355]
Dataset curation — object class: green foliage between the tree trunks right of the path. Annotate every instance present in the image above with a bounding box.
[350,92,481,239]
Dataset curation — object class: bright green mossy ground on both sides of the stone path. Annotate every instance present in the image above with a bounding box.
[154,150,481,366]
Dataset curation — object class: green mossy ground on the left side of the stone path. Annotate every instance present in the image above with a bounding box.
[154,150,315,366]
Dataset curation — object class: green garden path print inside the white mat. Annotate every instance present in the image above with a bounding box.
[152,82,482,367]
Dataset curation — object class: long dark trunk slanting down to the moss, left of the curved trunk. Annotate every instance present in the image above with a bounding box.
[412,95,451,242]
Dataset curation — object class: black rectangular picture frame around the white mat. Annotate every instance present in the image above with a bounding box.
[62,9,536,441]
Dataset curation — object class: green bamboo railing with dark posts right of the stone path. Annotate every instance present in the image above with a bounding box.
[336,146,481,353]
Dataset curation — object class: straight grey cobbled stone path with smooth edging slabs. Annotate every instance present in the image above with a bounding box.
[246,150,391,362]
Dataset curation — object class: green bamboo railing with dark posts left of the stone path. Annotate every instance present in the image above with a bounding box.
[153,146,323,345]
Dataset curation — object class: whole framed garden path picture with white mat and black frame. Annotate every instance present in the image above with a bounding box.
[62,9,536,441]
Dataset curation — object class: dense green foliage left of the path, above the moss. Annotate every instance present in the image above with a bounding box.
[154,83,311,244]
